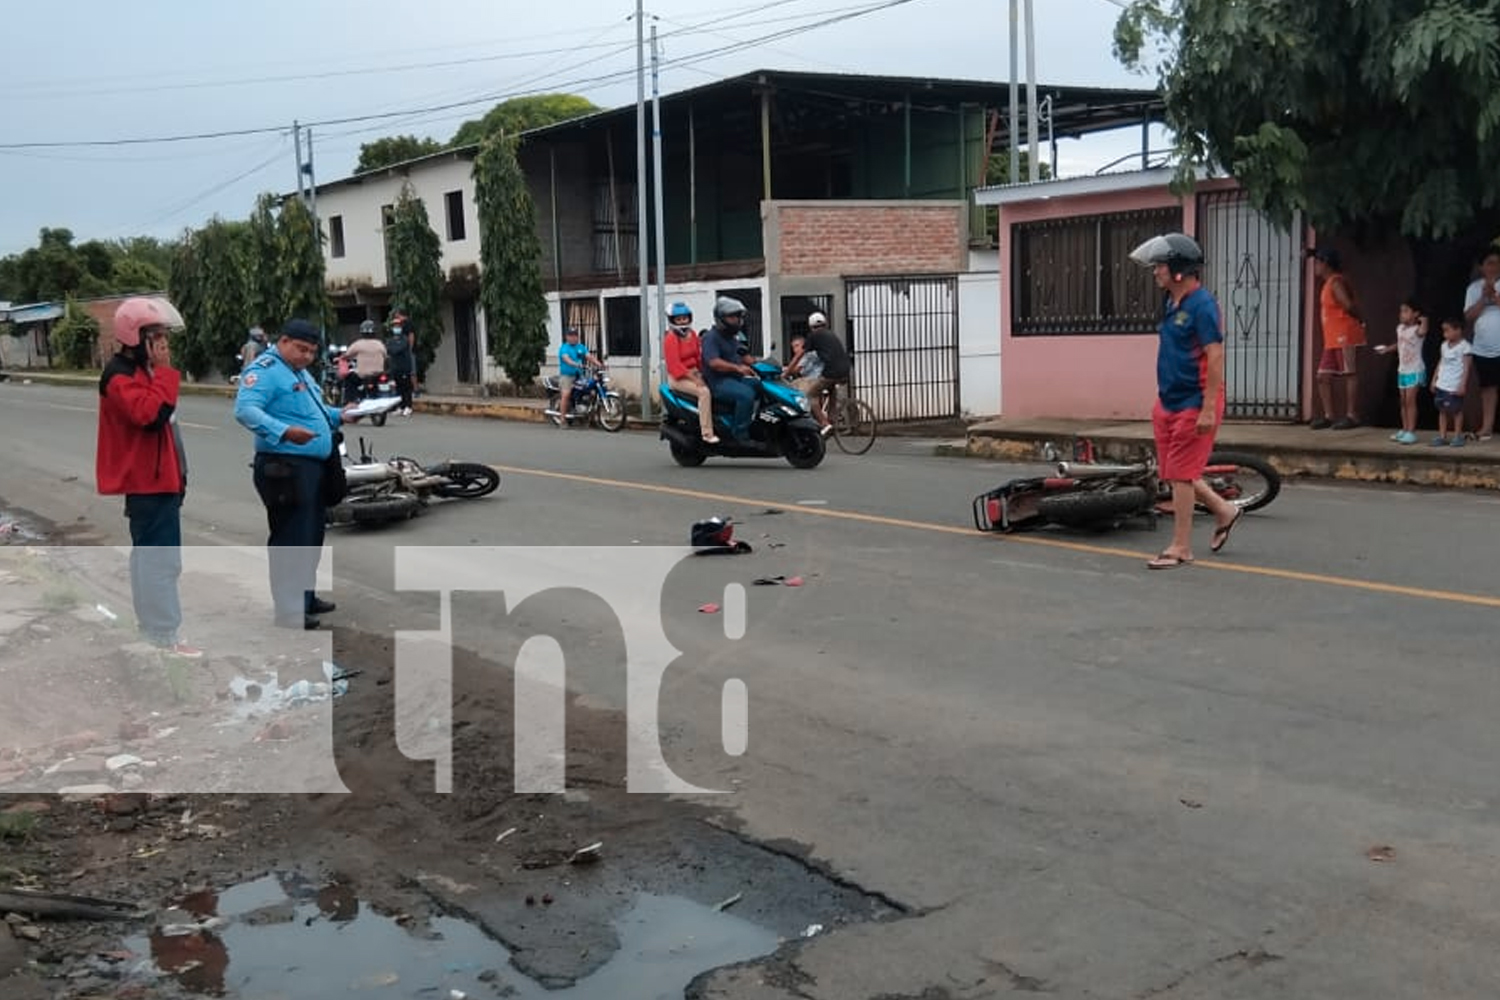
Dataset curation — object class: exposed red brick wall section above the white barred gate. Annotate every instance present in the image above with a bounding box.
[768,202,968,276]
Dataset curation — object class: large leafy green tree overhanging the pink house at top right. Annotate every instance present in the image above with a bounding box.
[1115,0,1500,240]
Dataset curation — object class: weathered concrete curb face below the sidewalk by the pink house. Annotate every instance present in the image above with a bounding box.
[939,427,1500,490]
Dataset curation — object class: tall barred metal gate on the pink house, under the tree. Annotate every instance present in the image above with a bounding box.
[1199,190,1302,420]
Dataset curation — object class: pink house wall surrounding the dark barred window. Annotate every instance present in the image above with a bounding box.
[1001,186,1208,420]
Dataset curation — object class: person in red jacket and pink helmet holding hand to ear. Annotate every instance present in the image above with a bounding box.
[95,298,203,660]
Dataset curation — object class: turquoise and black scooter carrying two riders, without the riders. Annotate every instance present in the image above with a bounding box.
[662,361,825,469]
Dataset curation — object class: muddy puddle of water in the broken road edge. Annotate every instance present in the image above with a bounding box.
[125,876,779,1000]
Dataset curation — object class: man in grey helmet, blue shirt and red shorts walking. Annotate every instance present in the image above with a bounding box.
[1130,232,1242,570]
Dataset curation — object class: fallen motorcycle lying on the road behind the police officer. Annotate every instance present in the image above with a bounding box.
[327,438,500,525]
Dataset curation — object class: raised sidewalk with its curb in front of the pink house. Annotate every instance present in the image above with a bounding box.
[945,420,1500,490]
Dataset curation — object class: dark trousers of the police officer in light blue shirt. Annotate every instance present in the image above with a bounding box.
[254,451,326,622]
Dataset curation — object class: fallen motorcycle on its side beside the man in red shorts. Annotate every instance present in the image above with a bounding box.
[974,451,1281,532]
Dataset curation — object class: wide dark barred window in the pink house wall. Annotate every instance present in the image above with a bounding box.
[1011,205,1182,336]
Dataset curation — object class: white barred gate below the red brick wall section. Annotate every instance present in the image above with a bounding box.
[845,276,960,420]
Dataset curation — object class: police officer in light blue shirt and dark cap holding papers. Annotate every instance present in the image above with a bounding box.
[234,319,356,630]
